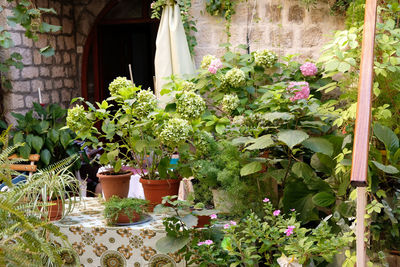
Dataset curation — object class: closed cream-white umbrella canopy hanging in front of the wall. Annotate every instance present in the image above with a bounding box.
[154,3,195,97]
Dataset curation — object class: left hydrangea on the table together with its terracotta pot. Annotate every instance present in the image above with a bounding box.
[67,77,140,199]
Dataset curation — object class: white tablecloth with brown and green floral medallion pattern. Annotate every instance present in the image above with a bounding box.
[54,198,184,267]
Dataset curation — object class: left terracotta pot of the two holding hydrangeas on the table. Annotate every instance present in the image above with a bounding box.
[96,171,132,200]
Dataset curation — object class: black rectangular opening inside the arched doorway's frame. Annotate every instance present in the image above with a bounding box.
[98,23,157,98]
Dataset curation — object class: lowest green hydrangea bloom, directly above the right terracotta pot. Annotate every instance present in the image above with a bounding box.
[160,118,191,149]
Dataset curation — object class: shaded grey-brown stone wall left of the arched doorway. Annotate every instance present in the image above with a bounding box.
[2,0,80,122]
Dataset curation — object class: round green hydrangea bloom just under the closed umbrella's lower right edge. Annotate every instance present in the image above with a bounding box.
[176,91,206,120]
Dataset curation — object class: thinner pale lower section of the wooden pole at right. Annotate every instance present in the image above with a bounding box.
[356,186,367,267]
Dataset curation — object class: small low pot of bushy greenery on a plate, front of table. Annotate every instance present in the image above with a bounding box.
[104,196,149,225]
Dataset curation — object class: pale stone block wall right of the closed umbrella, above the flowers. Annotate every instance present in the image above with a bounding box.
[191,0,344,66]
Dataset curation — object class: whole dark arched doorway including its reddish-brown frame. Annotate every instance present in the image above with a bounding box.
[81,0,158,102]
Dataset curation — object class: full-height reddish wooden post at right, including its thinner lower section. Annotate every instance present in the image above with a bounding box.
[351,0,377,267]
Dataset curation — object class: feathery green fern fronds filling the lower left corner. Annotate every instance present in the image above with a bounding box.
[0,135,80,267]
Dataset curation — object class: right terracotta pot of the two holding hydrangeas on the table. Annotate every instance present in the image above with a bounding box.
[139,178,181,211]
